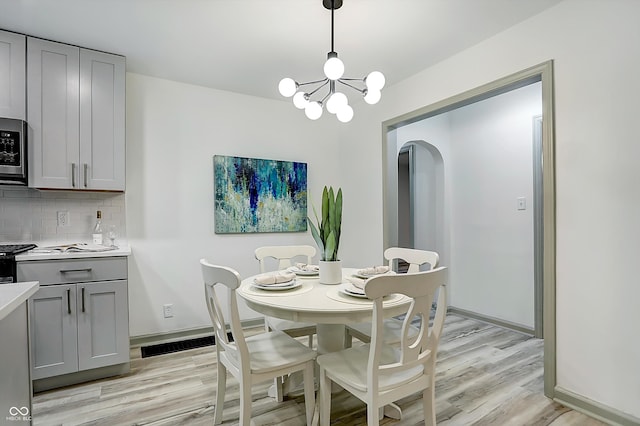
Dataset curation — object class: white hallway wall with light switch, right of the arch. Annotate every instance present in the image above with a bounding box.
[450,83,542,329]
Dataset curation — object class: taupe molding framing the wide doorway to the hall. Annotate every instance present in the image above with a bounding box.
[381,60,557,398]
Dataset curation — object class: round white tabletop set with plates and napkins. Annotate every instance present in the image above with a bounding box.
[237,268,411,324]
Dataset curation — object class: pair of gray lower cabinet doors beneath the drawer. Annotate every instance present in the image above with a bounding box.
[30,281,129,379]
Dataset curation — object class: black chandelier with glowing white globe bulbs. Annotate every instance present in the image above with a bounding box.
[278,0,385,123]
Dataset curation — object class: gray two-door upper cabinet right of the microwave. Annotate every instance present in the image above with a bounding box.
[27,37,125,191]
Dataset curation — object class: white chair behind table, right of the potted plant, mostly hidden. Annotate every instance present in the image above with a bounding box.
[345,247,440,347]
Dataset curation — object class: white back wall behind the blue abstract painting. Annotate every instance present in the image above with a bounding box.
[126,73,340,336]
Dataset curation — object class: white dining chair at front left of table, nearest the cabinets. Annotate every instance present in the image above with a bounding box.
[200,259,316,426]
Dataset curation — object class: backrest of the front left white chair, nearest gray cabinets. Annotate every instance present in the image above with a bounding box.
[200,259,249,371]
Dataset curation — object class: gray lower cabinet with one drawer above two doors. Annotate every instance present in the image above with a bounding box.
[18,257,130,390]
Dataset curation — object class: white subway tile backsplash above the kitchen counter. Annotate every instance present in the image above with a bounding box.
[0,187,126,244]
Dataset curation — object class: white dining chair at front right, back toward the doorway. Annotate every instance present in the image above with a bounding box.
[317,267,447,426]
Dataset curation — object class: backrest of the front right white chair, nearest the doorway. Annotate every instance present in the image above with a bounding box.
[364,267,447,392]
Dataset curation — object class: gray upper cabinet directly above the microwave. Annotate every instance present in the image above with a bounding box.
[0,31,27,120]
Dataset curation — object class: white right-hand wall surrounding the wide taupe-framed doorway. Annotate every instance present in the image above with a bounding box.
[340,0,640,418]
